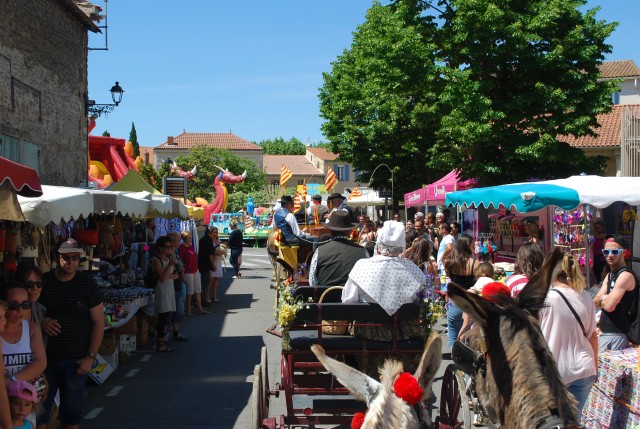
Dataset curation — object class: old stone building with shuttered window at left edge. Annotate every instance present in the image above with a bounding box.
[0,0,100,186]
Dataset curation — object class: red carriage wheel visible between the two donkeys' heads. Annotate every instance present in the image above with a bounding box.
[436,364,472,429]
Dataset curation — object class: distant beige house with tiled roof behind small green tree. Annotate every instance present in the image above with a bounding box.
[153,131,262,170]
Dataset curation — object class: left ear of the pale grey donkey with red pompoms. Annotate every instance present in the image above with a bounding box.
[311,344,380,406]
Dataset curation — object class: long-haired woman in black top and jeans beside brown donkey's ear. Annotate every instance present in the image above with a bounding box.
[444,234,476,347]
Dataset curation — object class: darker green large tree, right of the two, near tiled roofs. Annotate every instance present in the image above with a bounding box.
[429,0,615,184]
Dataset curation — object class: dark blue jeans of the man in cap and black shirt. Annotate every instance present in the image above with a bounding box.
[37,359,89,425]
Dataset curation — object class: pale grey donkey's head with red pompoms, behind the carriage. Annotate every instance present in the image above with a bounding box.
[311,332,442,429]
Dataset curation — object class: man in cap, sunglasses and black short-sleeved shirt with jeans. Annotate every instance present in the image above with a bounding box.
[38,239,104,428]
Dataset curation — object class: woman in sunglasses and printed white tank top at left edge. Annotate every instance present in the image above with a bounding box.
[0,281,47,427]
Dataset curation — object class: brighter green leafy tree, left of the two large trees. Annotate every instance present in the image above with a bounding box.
[319,2,443,196]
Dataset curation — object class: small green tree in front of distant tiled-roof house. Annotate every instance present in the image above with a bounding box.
[175,145,264,204]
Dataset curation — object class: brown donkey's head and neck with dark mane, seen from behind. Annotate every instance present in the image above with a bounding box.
[447,249,579,429]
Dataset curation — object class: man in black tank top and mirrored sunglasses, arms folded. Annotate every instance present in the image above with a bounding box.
[593,235,638,353]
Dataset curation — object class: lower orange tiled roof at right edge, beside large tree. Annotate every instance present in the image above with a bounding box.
[558,104,640,148]
